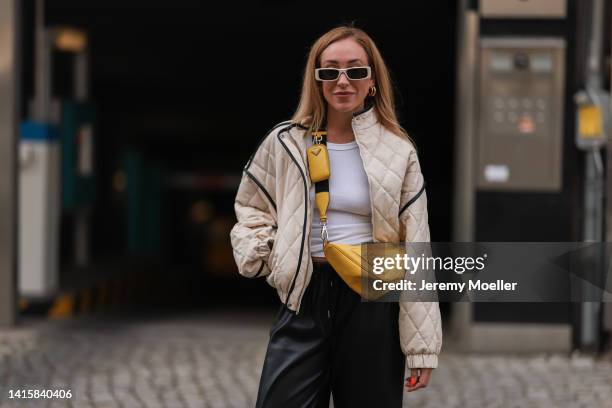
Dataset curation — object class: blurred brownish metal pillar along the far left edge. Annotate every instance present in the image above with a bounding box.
[0,0,21,326]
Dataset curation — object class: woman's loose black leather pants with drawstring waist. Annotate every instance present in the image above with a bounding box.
[256,264,405,408]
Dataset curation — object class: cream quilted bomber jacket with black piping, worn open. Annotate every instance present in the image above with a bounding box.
[231,108,442,368]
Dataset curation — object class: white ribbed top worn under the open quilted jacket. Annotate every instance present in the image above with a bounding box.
[307,138,372,257]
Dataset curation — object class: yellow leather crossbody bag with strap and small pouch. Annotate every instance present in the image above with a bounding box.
[307,131,405,300]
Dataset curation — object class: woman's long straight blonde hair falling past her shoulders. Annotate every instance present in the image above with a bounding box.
[291,26,414,144]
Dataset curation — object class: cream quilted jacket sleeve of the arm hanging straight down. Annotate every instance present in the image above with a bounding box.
[399,148,442,368]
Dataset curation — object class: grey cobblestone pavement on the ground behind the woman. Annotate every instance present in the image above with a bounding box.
[0,312,612,408]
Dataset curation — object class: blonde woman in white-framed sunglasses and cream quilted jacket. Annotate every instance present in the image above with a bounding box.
[231,27,442,408]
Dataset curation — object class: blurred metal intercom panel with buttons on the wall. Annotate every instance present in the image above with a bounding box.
[477,37,565,191]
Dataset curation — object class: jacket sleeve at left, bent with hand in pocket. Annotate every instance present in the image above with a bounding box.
[230,139,277,278]
